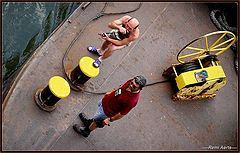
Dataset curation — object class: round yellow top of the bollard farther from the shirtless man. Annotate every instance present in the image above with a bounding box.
[48,76,70,98]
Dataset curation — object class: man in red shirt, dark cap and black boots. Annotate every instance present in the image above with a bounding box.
[73,75,147,137]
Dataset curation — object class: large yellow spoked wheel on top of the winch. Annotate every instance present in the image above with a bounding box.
[177,31,236,63]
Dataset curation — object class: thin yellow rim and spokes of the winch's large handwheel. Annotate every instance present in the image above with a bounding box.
[177,31,236,63]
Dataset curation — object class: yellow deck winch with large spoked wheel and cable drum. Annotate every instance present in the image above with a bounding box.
[163,31,236,100]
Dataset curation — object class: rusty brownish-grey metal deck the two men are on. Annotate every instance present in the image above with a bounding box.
[2,2,238,150]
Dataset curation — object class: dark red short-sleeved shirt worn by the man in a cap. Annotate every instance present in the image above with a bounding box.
[102,80,140,117]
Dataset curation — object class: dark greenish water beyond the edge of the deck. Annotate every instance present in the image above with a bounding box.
[2,2,80,97]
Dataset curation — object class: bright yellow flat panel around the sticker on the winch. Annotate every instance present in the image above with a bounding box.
[175,66,226,90]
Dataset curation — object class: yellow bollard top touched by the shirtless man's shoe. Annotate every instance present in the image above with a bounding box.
[79,56,100,78]
